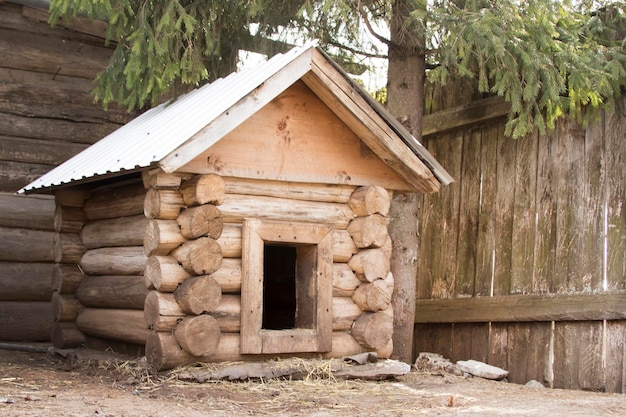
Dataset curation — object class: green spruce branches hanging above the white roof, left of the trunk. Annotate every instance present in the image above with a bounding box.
[50,0,300,109]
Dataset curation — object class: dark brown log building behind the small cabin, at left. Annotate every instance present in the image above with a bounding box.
[0,1,131,341]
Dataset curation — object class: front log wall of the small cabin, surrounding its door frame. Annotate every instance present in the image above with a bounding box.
[144,172,393,369]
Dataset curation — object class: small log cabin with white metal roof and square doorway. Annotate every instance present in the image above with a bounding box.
[21,44,451,370]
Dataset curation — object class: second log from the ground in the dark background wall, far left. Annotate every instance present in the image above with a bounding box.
[0,262,54,301]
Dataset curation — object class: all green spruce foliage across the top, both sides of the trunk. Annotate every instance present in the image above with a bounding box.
[51,0,626,137]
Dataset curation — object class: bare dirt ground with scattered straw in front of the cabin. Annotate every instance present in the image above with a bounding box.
[0,344,626,417]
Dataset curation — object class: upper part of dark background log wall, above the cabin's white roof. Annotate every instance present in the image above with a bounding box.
[0,2,131,192]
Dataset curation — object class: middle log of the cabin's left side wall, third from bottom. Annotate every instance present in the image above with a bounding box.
[80,246,148,275]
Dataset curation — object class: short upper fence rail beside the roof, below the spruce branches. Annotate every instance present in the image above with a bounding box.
[422,96,511,137]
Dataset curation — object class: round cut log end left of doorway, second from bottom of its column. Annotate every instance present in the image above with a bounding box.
[174,275,222,314]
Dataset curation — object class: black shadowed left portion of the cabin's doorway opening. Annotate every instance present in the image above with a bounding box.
[262,244,297,330]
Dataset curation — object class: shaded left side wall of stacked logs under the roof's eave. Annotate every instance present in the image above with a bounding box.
[62,177,148,347]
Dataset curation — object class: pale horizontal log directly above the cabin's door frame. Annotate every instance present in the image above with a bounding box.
[220,194,354,229]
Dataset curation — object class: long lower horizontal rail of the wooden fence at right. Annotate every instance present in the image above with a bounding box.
[415,293,626,323]
